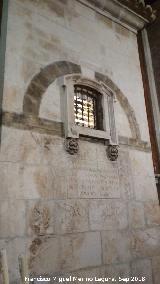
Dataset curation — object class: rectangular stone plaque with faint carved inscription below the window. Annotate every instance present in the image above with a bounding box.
[68,169,120,198]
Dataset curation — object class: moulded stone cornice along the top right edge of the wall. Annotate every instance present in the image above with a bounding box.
[79,0,156,33]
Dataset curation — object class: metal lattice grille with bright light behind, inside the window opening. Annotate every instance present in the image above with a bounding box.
[74,85,97,129]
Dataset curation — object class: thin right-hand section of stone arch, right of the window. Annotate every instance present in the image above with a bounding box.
[95,72,141,141]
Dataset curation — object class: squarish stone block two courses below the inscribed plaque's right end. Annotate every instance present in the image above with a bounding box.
[102,230,131,264]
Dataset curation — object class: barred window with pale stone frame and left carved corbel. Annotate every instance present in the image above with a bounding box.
[59,75,118,154]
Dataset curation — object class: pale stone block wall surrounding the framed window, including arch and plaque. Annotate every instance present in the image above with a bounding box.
[0,0,160,284]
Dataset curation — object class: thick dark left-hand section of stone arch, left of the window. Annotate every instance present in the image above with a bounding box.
[23,61,81,116]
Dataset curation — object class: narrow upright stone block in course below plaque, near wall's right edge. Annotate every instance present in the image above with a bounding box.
[128,201,145,229]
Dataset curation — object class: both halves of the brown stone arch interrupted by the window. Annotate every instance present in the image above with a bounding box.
[23,61,141,141]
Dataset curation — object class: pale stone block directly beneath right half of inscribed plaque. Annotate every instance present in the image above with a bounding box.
[89,200,128,230]
